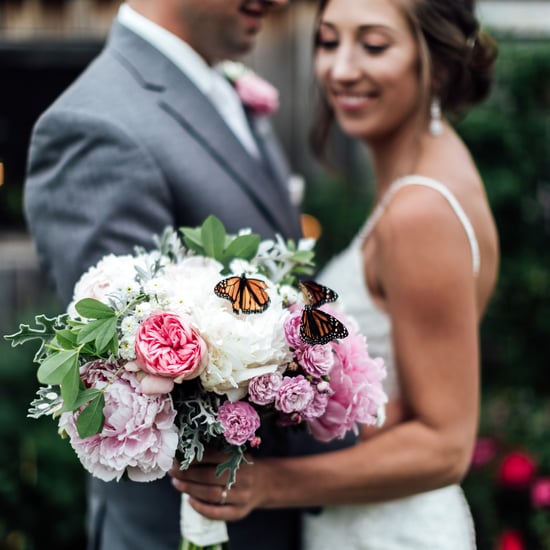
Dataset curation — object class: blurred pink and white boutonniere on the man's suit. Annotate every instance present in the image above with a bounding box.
[218,61,279,115]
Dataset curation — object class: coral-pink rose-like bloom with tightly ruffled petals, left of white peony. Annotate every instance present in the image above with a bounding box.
[136,312,207,383]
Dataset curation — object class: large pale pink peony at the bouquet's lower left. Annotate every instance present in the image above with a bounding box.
[59,361,178,481]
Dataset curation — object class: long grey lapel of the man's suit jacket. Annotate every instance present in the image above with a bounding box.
[108,23,302,236]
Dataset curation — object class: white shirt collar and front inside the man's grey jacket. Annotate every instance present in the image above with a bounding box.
[117,3,260,158]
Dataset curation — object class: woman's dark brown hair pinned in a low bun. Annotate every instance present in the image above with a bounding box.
[311,0,497,162]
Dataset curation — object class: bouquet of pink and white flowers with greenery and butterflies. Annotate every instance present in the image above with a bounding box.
[7,216,386,548]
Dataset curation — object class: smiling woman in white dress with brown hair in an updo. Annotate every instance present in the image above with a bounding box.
[174,0,499,550]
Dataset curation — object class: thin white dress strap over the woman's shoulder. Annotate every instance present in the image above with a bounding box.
[357,174,481,277]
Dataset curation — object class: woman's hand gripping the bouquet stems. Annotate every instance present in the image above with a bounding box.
[168,451,263,521]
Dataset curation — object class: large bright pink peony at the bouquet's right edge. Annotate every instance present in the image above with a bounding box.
[308,326,387,441]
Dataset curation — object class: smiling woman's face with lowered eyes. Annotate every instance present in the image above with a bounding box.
[315,0,423,141]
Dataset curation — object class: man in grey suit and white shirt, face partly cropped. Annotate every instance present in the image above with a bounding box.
[25,0,308,550]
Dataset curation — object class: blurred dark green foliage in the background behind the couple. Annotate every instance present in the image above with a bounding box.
[0,38,550,550]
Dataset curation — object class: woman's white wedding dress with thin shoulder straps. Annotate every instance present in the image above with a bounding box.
[302,176,479,550]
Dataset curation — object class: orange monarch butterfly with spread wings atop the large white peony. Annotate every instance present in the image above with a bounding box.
[214,274,270,313]
